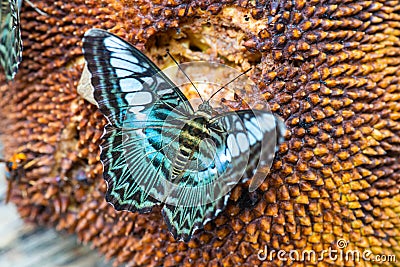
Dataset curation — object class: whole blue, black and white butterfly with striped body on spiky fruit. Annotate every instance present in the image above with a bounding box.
[83,29,285,241]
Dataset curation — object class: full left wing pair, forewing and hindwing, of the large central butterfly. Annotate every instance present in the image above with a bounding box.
[83,29,193,212]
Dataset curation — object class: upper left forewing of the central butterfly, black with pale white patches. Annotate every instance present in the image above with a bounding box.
[83,29,192,128]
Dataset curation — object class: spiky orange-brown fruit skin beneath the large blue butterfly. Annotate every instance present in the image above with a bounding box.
[0,0,400,266]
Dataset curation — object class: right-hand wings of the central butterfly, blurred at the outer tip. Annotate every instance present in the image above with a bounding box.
[162,110,285,241]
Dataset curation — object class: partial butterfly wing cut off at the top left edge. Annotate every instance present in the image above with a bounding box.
[0,0,22,80]
